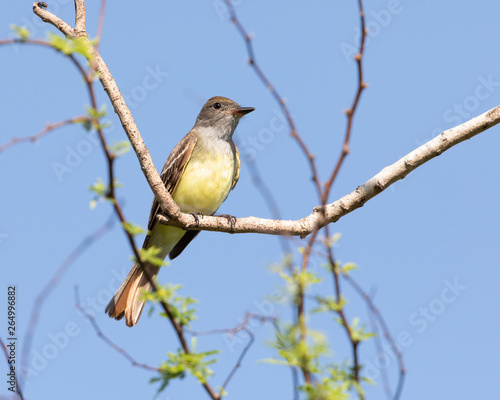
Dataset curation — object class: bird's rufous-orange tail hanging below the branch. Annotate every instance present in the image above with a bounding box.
[106,263,160,326]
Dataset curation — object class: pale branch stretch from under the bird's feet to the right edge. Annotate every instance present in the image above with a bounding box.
[159,106,500,237]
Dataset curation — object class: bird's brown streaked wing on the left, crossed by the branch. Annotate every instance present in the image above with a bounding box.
[144,132,197,238]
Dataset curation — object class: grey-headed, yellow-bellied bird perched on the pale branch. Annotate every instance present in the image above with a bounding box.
[105,96,255,327]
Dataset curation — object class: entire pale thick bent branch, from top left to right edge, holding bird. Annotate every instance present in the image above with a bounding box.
[33,3,500,237]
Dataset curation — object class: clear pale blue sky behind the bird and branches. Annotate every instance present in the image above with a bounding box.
[0,0,500,400]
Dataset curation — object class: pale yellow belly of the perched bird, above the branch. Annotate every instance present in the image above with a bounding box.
[172,148,234,215]
